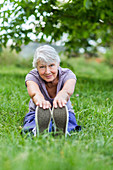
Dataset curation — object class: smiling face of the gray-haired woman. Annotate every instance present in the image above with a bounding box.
[37,61,59,82]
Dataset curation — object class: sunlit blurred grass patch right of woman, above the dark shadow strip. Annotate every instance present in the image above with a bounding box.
[68,56,113,80]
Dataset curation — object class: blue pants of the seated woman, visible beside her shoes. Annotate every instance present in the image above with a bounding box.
[23,111,81,132]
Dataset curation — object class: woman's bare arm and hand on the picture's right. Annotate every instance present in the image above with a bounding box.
[53,79,76,108]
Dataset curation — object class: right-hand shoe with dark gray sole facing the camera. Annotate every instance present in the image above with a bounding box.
[52,106,69,137]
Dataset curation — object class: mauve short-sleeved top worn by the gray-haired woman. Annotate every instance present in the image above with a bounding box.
[25,67,76,113]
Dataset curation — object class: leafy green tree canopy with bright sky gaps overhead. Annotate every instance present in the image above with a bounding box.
[0,0,113,53]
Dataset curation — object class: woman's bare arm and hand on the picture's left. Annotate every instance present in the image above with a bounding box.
[26,81,51,109]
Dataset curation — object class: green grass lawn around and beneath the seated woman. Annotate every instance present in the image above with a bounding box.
[0,59,113,170]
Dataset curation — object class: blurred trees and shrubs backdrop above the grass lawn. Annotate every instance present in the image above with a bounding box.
[0,0,113,67]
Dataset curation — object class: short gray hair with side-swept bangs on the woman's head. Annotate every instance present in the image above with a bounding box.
[33,45,60,68]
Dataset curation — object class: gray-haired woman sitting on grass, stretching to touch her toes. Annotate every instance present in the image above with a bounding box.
[23,45,81,135]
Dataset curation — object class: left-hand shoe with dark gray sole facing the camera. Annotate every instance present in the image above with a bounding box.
[35,106,51,136]
